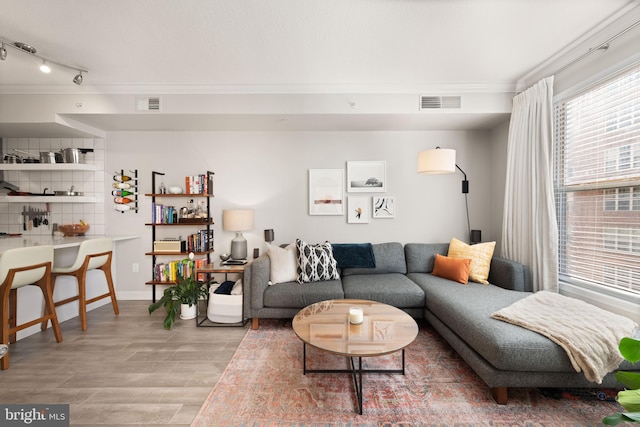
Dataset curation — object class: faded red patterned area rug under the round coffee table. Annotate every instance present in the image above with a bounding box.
[192,320,620,427]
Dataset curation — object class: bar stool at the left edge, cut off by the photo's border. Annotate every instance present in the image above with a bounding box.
[0,245,62,370]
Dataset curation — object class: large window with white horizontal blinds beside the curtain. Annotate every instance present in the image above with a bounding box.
[554,64,640,296]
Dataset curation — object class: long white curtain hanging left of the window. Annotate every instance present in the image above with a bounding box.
[501,76,558,292]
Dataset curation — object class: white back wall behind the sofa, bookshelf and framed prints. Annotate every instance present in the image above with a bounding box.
[105,131,503,299]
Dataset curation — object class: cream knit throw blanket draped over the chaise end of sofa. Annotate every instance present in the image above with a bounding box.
[491,291,638,384]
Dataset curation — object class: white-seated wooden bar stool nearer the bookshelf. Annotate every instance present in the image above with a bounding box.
[49,238,120,331]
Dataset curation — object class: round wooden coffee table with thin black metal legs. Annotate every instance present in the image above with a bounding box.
[293,299,418,414]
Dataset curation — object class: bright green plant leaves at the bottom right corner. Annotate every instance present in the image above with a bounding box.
[602,337,640,426]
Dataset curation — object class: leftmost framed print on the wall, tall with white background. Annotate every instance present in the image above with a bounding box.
[309,169,344,215]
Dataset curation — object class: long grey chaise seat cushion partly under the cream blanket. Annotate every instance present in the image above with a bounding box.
[408,273,575,372]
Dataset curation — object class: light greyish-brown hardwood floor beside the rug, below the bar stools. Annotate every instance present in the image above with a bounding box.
[0,301,248,426]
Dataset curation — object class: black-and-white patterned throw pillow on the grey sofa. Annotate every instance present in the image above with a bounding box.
[296,239,340,283]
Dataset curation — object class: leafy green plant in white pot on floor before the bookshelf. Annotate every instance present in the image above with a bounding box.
[149,253,207,329]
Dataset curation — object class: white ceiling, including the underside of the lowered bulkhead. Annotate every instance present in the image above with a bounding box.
[0,0,638,136]
